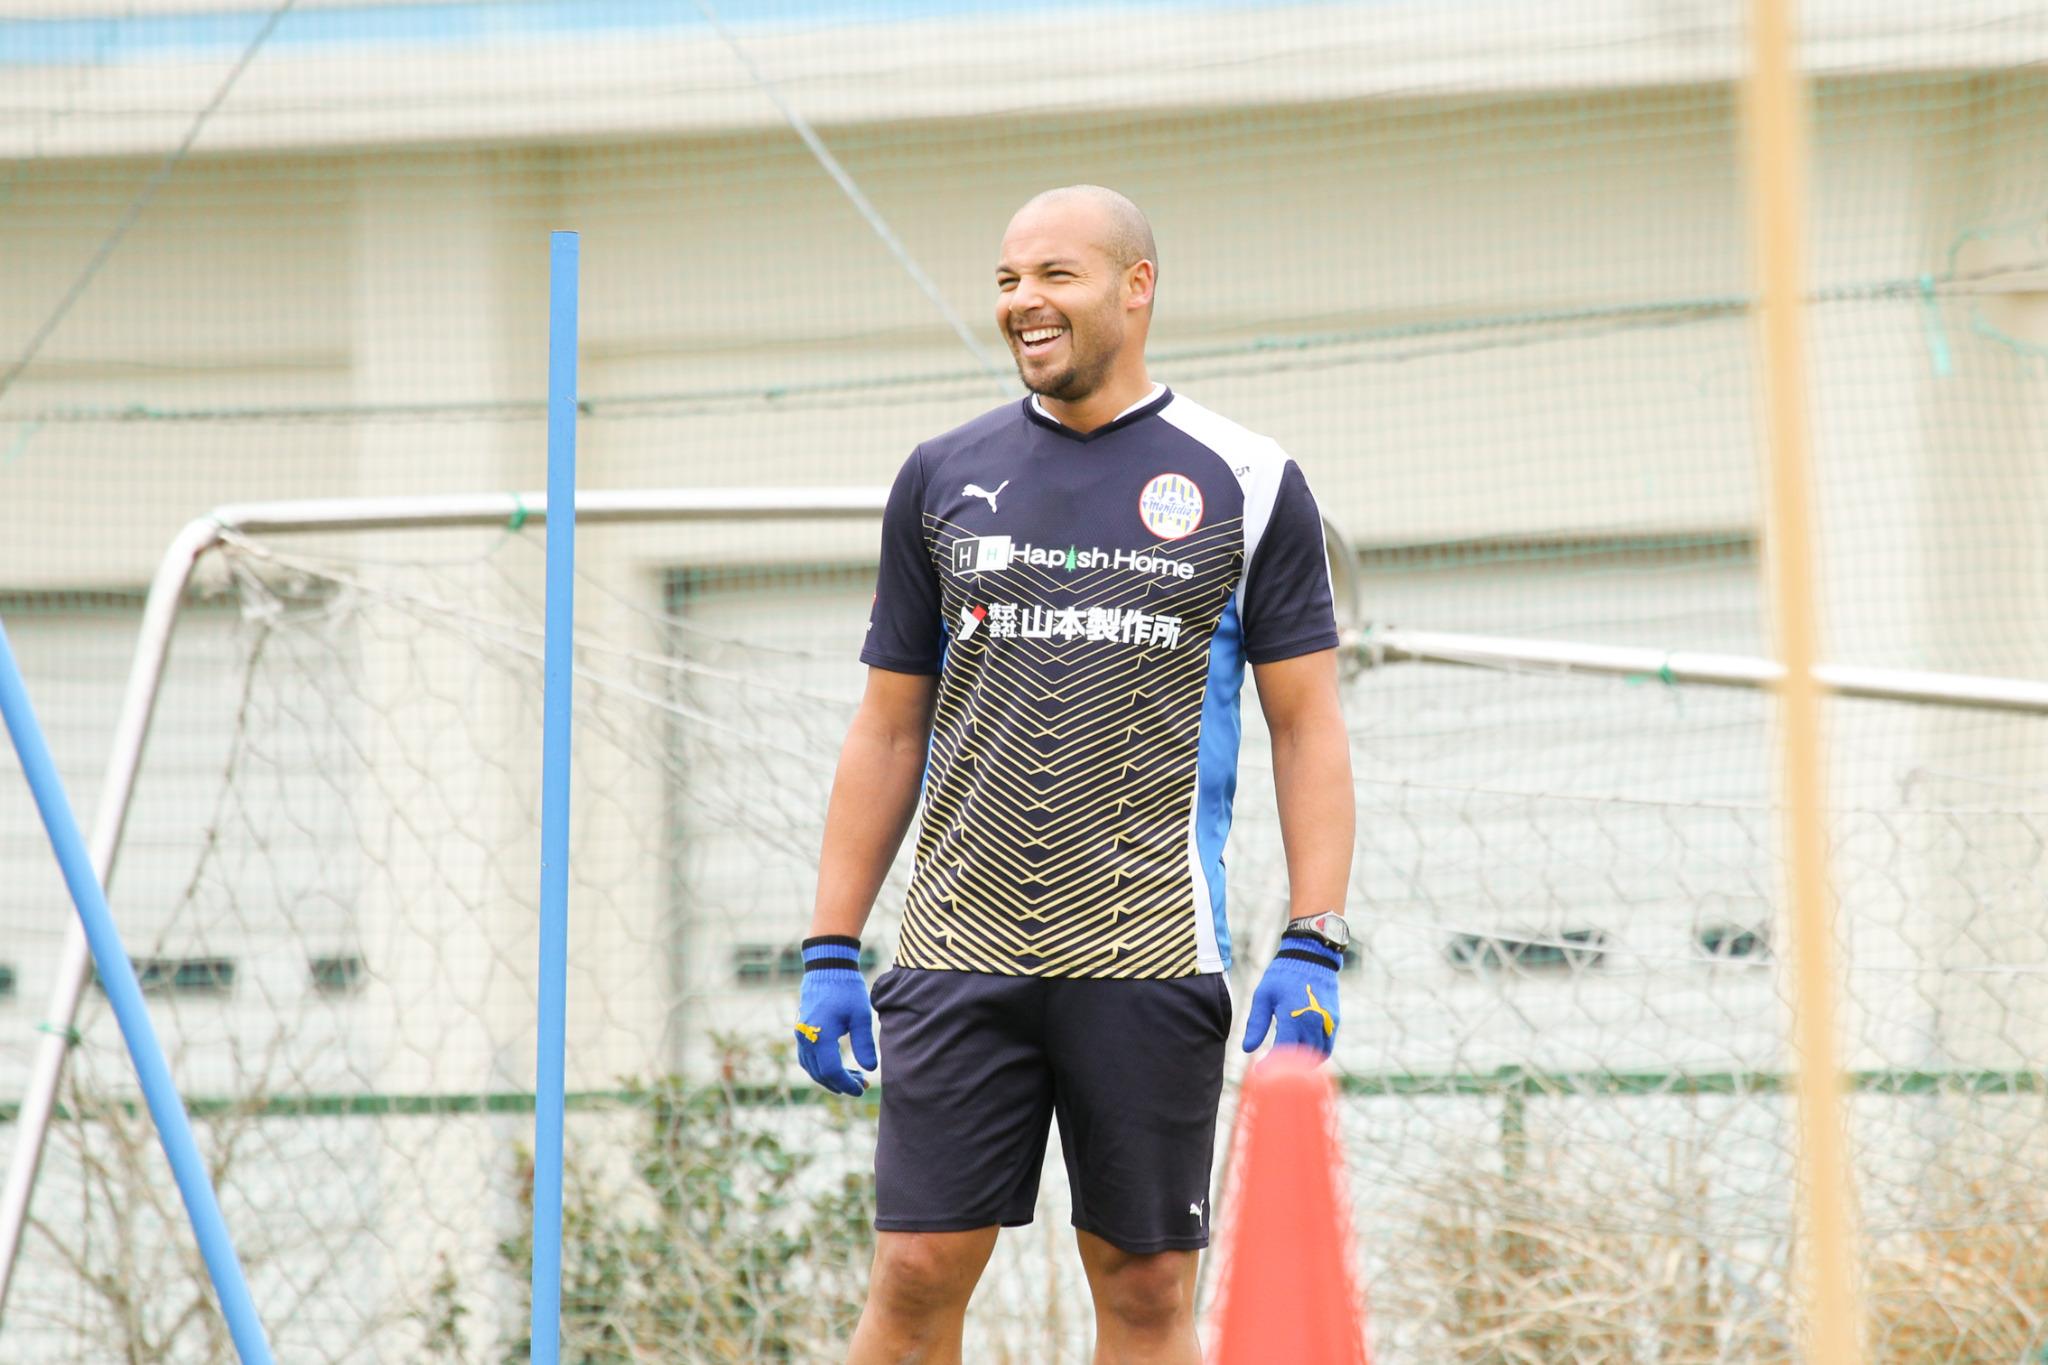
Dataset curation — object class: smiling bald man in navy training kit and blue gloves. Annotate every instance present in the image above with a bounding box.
[797,184,1352,1365]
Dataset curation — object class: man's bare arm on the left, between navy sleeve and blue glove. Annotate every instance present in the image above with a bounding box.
[811,667,938,937]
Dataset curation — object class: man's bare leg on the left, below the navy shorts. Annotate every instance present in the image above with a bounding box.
[846,1228,997,1365]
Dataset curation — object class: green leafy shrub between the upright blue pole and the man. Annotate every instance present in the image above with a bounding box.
[498,1040,874,1365]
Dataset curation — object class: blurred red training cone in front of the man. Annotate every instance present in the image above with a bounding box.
[1208,1046,1368,1365]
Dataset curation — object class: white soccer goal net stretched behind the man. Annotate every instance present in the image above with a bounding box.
[8,507,2048,1365]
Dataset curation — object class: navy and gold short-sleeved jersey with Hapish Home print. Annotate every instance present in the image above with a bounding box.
[860,387,1337,976]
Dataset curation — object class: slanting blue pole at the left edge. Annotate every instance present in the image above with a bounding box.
[0,626,270,1365]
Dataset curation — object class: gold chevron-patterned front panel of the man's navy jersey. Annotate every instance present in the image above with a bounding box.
[897,514,1243,976]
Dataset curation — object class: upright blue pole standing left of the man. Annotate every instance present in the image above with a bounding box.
[530,231,578,1365]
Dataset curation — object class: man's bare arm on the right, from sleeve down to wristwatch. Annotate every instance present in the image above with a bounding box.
[1251,649,1356,919]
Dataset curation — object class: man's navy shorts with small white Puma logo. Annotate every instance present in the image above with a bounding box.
[872,966,1231,1254]
